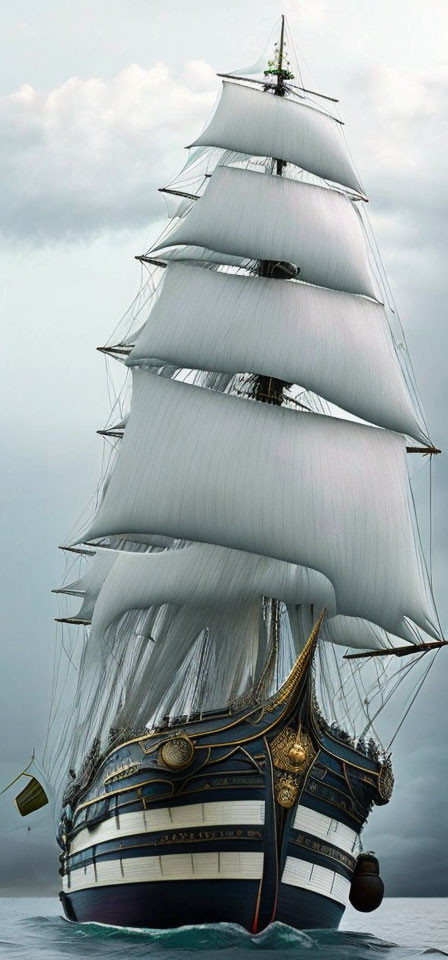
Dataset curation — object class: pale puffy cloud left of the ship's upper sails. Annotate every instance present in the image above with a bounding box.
[0,61,216,243]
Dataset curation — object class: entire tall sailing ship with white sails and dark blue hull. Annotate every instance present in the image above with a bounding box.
[11,17,444,932]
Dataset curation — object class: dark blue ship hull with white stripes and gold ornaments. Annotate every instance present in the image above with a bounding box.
[61,660,390,932]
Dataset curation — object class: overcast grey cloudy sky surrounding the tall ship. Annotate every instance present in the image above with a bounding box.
[0,0,448,896]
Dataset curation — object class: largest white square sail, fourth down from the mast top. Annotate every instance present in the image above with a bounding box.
[82,368,438,636]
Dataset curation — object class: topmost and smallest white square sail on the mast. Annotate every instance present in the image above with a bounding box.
[191,81,362,192]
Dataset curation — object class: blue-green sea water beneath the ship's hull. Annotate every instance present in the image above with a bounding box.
[0,898,448,960]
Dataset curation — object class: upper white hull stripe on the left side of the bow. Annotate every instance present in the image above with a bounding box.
[69,800,264,854]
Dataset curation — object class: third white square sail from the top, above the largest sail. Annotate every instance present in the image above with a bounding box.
[126,264,428,443]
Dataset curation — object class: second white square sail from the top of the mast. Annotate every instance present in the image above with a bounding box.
[152,167,378,298]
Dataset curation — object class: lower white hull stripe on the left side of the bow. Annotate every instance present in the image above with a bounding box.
[62,852,263,893]
